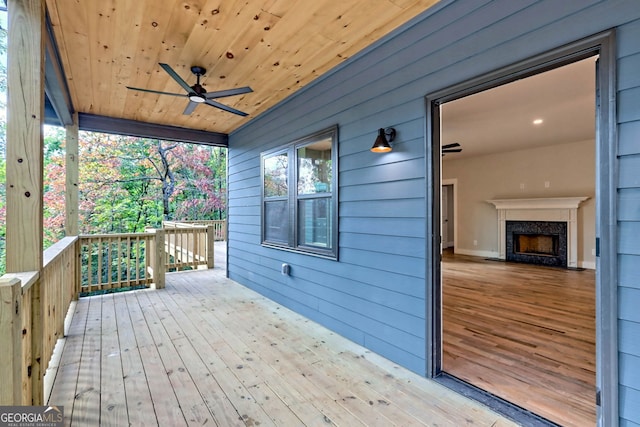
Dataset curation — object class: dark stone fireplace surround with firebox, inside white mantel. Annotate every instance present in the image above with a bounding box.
[505,221,567,268]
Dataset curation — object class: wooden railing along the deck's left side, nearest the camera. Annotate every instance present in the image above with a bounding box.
[0,237,77,405]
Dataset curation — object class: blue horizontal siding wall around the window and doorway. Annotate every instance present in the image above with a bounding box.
[229,0,640,426]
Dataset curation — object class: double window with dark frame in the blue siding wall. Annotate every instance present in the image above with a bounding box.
[261,127,338,258]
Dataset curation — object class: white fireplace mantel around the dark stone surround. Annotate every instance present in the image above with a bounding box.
[487,197,589,268]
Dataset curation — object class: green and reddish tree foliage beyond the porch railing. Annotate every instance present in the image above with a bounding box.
[0,127,226,274]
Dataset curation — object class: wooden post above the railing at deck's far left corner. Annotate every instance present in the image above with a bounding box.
[65,113,79,236]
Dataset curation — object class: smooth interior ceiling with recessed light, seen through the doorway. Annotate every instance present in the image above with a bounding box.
[441,57,596,161]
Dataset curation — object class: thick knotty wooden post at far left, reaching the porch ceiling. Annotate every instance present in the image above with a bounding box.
[3,0,48,405]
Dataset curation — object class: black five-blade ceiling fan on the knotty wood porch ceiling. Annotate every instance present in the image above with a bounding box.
[127,63,253,116]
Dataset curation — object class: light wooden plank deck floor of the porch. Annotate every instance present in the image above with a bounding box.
[49,269,514,426]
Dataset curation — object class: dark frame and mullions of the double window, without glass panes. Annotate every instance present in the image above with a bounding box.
[260,125,339,260]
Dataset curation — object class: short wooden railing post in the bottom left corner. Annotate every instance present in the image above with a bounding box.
[0,276,23,405]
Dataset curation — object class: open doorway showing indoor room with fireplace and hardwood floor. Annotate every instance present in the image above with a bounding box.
[428,32,614,425]
